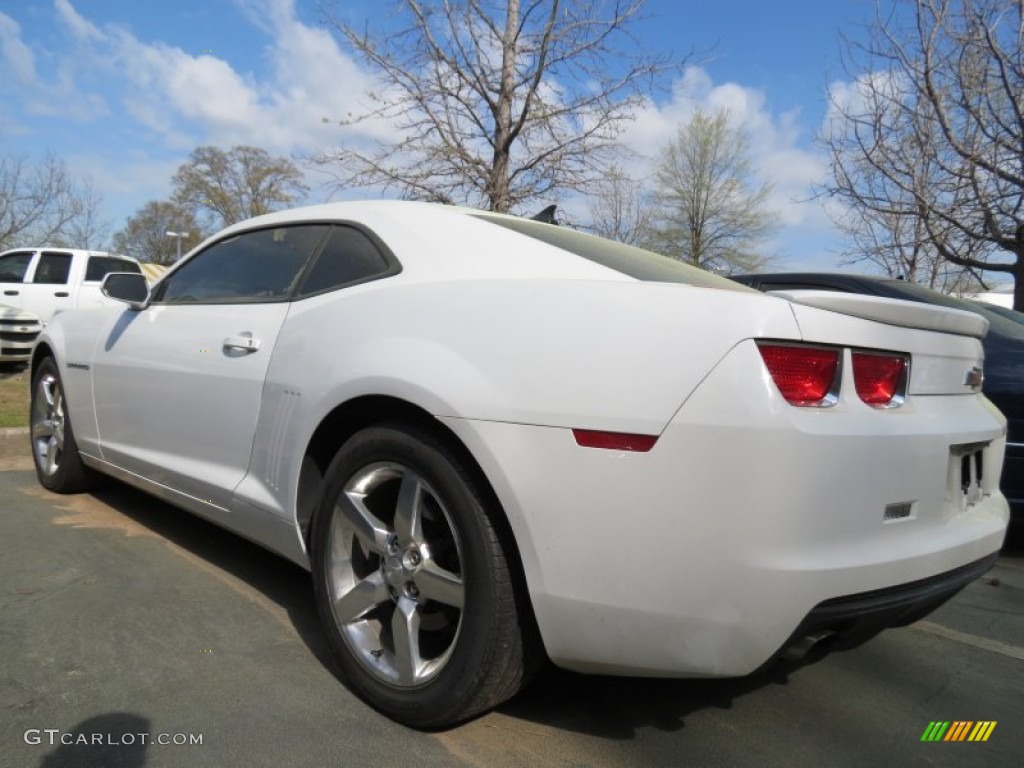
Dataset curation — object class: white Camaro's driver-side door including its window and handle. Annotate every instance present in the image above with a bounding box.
[91,225,328,508]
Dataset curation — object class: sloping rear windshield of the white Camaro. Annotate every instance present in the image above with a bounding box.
[471,213,756,293]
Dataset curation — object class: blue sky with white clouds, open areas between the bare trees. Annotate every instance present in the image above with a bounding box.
[0,0,871,268]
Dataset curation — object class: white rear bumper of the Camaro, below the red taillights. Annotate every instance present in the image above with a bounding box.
[447,343,1008,677]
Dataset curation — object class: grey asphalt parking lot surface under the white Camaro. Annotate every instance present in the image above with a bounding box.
[0,433,1024,768]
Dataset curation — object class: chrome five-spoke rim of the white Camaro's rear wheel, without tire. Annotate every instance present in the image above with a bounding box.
[325,462,465,688]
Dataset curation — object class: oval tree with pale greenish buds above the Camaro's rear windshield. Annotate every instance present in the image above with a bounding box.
[651,111,778,272]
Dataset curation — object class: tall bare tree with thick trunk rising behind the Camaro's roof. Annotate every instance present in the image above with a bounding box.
[313,0,673,212]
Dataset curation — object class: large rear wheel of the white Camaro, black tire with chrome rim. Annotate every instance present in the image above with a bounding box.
[312,424,536,728]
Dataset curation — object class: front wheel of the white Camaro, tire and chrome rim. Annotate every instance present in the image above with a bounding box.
[29,357,95,494]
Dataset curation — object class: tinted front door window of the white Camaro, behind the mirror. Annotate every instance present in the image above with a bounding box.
[155,224,329,304]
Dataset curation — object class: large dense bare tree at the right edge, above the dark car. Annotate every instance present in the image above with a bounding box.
[823,0,1024,310]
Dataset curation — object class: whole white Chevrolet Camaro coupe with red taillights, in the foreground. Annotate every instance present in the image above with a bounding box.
[31,202,1008,727]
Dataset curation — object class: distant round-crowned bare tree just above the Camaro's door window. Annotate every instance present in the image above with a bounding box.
[172,145,307,227]
